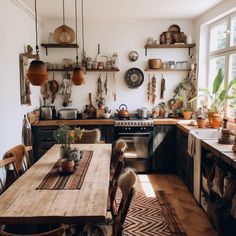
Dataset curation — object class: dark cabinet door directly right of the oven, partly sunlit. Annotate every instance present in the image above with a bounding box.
[153,125,176,173]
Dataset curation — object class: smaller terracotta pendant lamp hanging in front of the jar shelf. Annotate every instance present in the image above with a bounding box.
[71,0,85,86]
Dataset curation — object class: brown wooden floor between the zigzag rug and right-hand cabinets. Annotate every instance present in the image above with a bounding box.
[145,174,217,236]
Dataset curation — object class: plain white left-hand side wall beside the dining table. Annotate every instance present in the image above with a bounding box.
[0,0,39,159]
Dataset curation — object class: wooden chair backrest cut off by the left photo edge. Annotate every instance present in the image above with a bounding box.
[0,156,19,194]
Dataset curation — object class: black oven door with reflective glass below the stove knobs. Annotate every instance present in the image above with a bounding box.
[115,127,153,172]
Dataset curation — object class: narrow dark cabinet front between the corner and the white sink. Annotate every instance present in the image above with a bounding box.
[176,128,193,192]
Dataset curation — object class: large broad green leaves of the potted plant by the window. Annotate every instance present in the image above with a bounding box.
[190,68,236,112]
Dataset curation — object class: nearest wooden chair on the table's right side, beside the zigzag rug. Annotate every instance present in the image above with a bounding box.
[83,169,137,236]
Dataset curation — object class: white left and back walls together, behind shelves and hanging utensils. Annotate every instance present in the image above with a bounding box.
[0,0,193,157]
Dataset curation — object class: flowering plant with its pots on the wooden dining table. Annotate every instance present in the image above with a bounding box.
[53,125,83,172]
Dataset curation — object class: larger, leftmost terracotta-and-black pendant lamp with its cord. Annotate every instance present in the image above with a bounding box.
[27,0,48,86]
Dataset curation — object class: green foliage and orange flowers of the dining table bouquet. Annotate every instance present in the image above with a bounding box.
[53,125,83,158]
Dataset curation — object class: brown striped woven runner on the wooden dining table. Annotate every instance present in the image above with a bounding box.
[37,150,93,190]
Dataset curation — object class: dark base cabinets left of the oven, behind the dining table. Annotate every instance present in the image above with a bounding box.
[32,125,114,161]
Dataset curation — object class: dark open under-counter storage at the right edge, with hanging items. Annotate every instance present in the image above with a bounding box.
[200,147,236,236]
